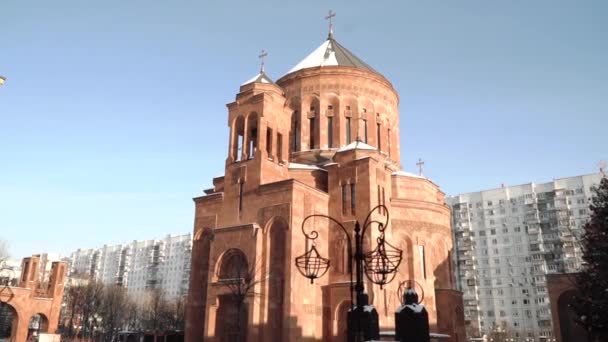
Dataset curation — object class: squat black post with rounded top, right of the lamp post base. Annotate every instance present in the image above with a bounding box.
[395,287,431,342]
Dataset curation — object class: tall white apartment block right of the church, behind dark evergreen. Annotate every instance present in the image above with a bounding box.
[447,173,602,341]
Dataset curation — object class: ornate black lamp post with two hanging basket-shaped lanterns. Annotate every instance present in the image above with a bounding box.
[295,204,403,336]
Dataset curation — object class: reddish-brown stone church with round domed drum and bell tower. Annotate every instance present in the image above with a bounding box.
[186,22,465,342]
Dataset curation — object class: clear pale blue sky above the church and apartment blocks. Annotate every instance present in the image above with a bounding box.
[0,0,608,257]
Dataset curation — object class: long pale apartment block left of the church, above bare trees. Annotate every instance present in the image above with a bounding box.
[70,234,192,297]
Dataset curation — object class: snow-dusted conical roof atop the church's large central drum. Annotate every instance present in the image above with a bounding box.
[287,34,377,74]
